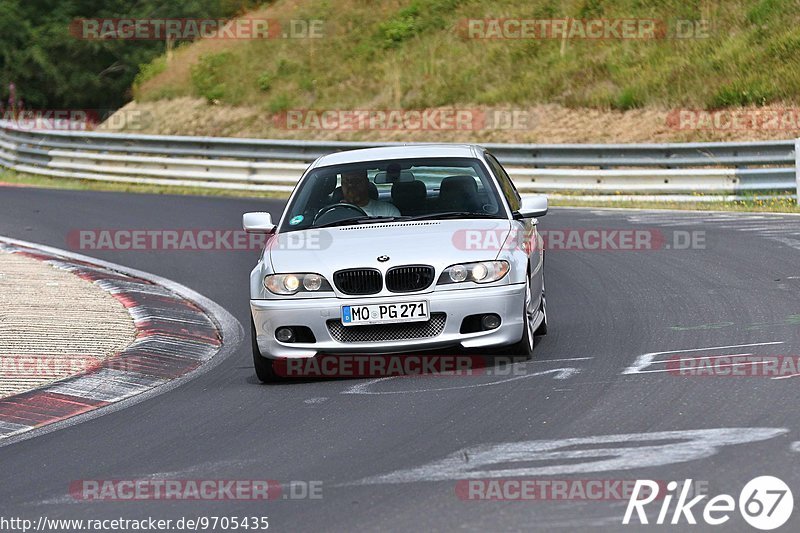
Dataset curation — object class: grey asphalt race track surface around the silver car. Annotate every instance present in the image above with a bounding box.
[0,188,800,531]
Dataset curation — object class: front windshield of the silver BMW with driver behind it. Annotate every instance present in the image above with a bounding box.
[281,158,505,232]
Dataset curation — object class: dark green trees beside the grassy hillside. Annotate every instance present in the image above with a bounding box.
[0,0,259,110]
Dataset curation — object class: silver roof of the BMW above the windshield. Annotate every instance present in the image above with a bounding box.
[311,144,484,168]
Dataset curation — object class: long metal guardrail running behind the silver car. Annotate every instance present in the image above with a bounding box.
[0,121,800,198]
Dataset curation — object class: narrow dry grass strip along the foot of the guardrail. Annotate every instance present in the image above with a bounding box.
[0,170,800,213]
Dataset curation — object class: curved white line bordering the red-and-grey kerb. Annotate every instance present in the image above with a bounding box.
[0,236,244,447]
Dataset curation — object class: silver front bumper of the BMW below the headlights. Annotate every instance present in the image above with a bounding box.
[250,283,525,359]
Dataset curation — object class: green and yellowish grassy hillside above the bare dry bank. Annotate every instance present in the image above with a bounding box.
[134,0,800,112]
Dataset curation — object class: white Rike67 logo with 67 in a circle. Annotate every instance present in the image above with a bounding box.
[622,476,794,531]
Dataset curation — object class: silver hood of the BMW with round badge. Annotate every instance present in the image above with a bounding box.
[268,219,511,276]
